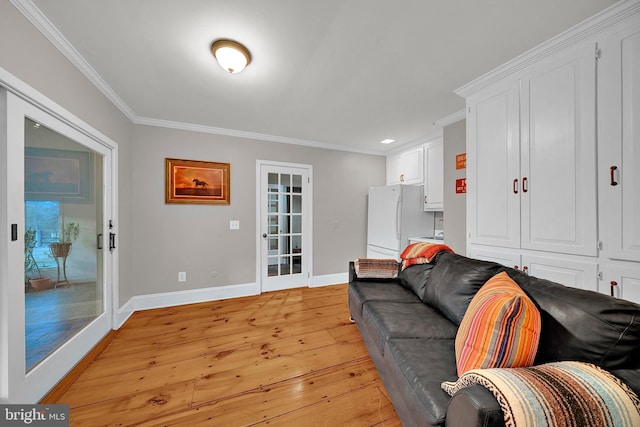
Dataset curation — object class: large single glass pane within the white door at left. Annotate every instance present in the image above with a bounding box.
[24,118,104,372]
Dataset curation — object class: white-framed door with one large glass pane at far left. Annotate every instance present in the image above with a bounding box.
[0,88,117,403]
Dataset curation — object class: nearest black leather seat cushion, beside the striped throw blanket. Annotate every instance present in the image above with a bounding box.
[384,338,456,426]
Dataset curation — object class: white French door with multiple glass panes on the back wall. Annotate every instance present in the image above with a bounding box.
[257,161,312,292]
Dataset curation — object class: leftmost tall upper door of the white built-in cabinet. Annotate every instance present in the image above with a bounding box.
[467,81,520,248]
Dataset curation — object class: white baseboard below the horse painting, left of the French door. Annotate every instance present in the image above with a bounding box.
[118,283,260,328]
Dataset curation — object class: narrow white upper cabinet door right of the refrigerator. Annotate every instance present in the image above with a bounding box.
[424,138,444,211]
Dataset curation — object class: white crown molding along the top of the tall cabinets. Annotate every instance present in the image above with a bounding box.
[454,0,640,98]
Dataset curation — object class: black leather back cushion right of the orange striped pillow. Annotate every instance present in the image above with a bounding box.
[508,269,640,370]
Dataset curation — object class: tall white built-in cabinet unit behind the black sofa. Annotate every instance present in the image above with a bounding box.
[457,1,640,302]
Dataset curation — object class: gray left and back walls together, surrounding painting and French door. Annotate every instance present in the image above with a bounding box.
[0,1,385,305]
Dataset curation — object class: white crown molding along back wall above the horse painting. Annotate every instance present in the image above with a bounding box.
[133,117,385,156]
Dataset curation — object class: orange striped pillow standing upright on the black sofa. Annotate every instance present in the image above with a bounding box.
[455,271,541,376]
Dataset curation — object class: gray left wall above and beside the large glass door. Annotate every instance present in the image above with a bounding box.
[0,0,133,303]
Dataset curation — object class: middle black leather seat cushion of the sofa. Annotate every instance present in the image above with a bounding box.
[362,301,458,358]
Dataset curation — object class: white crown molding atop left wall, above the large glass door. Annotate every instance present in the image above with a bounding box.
[9,0,135,121]
